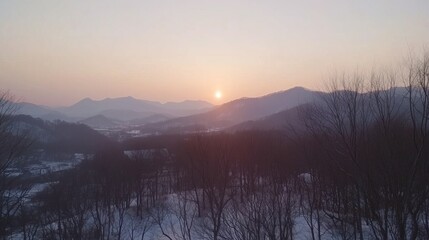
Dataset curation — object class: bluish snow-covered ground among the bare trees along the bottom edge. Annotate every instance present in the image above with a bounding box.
[8,189,372,240]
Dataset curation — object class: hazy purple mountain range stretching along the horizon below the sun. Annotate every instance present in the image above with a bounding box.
[11,87,406,135]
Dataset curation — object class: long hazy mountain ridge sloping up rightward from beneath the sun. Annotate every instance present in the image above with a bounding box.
[143,87,319,132]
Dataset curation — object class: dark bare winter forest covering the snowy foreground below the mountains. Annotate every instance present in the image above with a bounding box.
[15,121,429,239]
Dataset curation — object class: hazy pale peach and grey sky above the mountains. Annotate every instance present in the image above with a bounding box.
[0,0,429,105]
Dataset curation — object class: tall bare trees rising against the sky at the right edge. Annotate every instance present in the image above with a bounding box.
[305,53,429,240]
